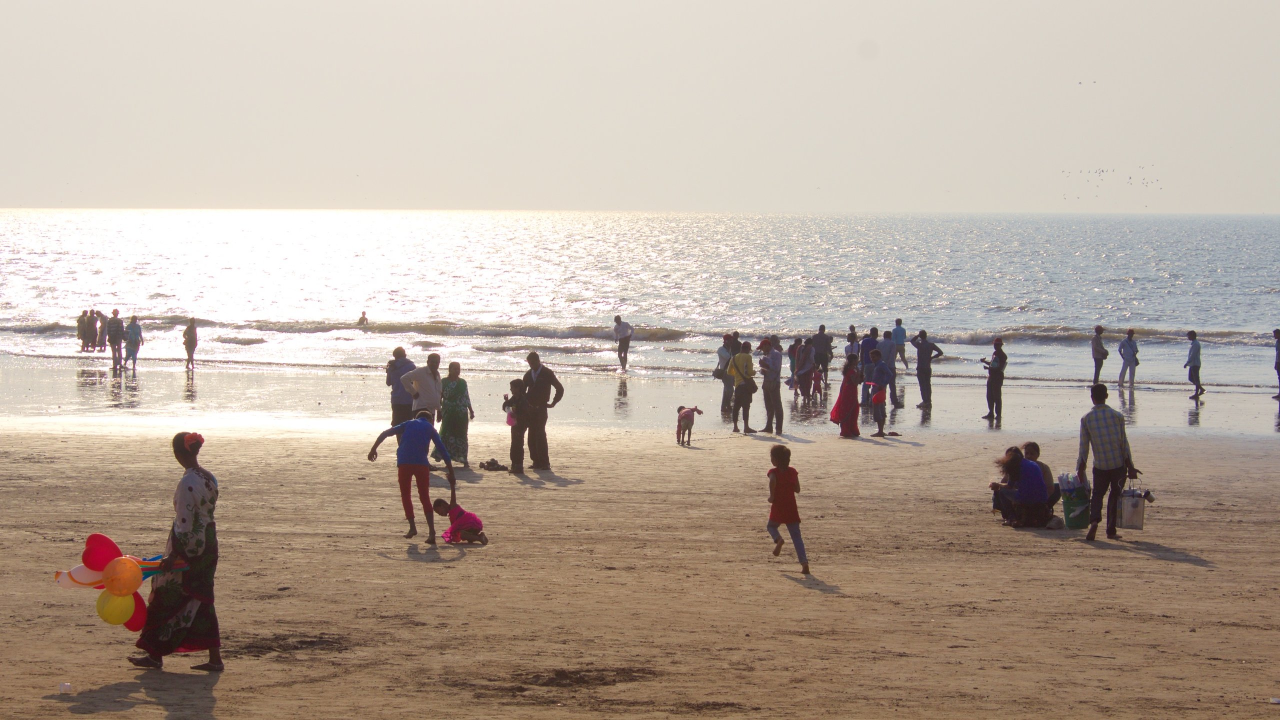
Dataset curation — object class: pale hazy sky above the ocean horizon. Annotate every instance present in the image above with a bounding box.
[0,0,1280,213]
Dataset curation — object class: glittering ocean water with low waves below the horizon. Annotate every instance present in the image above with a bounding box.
[0,210,1280,392]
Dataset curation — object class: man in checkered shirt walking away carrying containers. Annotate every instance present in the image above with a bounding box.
[1075,384,1140,542]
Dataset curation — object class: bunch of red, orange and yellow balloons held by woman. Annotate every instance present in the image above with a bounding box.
[54,533,187,633]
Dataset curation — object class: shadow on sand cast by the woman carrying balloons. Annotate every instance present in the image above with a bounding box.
[45,656,221,720]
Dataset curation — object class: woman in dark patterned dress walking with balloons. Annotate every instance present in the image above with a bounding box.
[129,433,223,673]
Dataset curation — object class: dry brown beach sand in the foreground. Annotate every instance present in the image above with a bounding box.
[0,421,1280,717]
